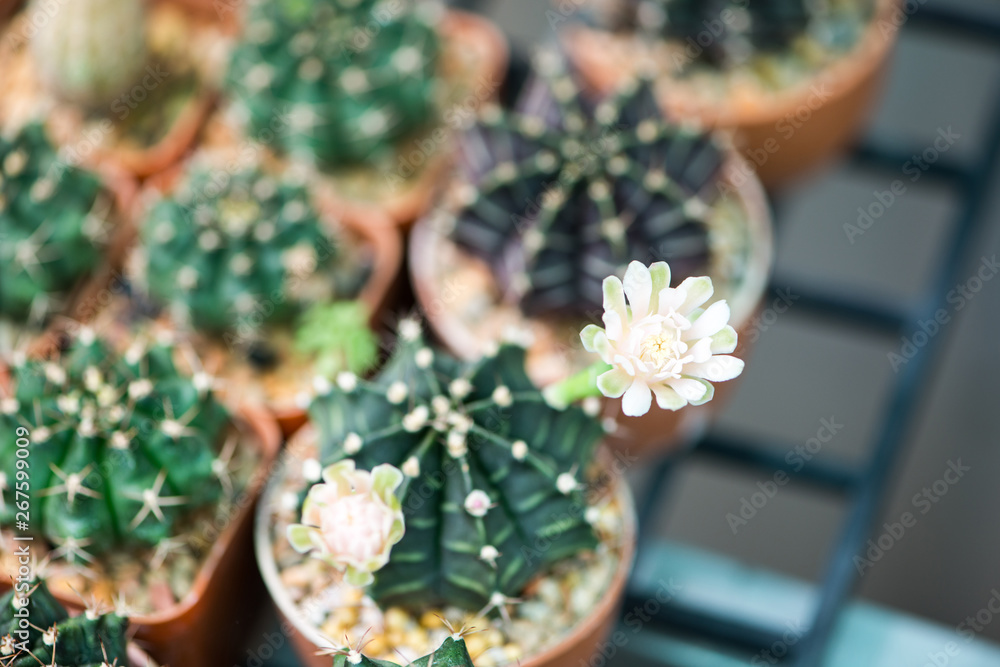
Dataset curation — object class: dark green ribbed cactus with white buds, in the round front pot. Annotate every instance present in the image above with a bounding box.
[310,320,603,610]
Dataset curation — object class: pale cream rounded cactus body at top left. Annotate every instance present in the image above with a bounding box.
[29,0,147,110]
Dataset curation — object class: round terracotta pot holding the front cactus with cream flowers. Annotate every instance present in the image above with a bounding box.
[254,426,637,667]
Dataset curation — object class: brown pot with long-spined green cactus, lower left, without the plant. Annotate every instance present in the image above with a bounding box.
[0,405,281,667]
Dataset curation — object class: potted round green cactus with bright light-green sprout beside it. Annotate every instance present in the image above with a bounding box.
[129,148,402,433]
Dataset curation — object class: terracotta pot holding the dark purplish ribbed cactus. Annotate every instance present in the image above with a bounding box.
[409,154,772,456]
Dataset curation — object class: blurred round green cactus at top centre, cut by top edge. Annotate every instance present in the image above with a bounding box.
[227,0,440,168]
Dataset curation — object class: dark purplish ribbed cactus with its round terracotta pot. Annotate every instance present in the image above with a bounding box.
[410,53,771,460]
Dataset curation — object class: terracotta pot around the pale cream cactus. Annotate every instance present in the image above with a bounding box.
[0,0,223,179]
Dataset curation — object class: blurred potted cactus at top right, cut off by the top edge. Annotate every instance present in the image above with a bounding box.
[565,0,902,187]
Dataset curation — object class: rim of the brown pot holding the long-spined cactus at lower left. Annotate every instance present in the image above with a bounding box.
[0,403,281,626]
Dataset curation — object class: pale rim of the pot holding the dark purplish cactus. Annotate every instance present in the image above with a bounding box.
[409,150,774,359]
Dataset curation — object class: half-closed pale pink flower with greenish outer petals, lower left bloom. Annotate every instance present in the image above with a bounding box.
[288,459,405,587]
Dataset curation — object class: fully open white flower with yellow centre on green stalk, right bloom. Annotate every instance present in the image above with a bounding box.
[580,262,743,417]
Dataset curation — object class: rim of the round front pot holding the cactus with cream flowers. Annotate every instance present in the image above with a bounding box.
[254,424,638,667]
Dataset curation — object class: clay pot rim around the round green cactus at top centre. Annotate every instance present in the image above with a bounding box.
[312,8,510,229]
